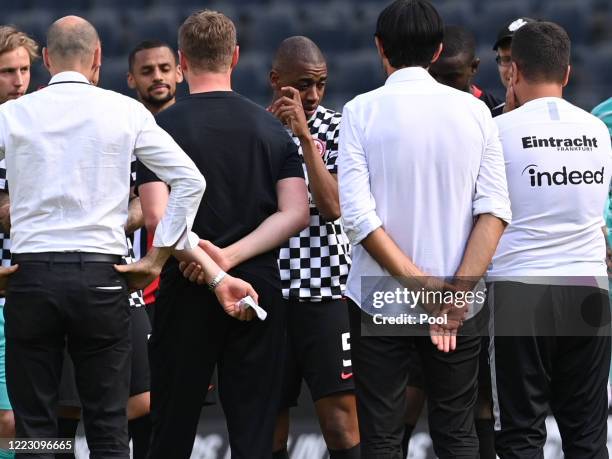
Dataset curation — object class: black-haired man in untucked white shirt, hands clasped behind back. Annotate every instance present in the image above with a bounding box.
[338,0,511,459]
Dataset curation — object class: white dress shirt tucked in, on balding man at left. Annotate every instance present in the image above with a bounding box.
[0,72,205,255]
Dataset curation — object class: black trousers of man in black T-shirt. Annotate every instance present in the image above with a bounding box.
[149,274,286,459]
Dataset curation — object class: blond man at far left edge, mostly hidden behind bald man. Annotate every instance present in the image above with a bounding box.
[0,25,38,459]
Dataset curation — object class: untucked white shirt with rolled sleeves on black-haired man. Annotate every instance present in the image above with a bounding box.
[338,67,511,306]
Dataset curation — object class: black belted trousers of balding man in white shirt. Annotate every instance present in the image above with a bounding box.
[4,257,130,459]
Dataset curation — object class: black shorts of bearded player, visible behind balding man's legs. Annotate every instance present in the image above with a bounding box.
[59,307,151,407]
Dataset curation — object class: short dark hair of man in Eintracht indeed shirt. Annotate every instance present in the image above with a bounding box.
[512,21,571,83]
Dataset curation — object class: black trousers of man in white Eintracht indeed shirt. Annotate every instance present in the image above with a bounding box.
[489,282,611,459]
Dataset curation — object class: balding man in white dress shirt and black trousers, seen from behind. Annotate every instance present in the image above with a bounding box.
[0,16,256,458]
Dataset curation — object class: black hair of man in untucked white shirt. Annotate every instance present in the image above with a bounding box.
[376,0,444,69]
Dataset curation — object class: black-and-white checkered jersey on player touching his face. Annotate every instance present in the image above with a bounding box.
[278,106,351,301]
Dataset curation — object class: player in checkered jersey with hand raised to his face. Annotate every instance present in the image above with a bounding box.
[269,36,359,459]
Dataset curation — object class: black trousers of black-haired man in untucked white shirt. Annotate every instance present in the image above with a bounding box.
[349,300,481,459]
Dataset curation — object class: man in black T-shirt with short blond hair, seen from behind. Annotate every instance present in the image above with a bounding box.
[137,11,309,459]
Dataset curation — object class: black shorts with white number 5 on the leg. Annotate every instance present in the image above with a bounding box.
[282,300,355,407]
